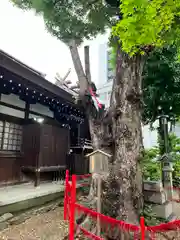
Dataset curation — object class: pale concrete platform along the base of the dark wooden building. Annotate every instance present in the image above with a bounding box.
[0,183,64,215]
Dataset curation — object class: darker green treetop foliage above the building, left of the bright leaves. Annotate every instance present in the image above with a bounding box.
[11,0,116,44]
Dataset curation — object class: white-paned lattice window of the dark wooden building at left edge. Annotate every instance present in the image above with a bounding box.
[0,121,22,151]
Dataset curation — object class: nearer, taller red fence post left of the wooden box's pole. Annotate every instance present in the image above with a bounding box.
[69,175,76,240]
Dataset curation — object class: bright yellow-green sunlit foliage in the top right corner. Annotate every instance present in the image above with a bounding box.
[113,0,180,55]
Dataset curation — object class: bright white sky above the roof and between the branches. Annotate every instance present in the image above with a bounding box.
[0,0,108,83]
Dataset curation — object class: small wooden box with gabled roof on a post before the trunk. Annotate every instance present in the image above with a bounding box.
[86,149,112,173]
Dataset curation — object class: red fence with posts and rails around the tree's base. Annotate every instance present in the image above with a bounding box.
[64,171,180,240]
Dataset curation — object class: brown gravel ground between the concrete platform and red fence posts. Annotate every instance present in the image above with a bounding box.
[0,208,68,240]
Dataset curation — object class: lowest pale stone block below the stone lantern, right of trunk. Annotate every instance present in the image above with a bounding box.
[152,202,173,219]
